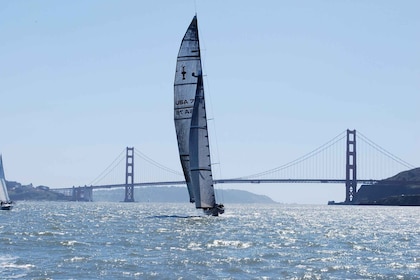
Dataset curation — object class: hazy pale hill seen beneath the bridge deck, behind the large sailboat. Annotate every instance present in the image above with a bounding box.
[93,187,276,204]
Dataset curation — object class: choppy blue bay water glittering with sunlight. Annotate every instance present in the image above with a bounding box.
[0,202,420,279]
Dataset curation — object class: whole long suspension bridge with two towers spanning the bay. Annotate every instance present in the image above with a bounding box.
[51,129,420,204]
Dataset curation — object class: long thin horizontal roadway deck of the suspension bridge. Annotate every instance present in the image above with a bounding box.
[51,178,386,191]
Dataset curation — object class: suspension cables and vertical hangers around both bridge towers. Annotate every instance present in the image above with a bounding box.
[89,131,414,189]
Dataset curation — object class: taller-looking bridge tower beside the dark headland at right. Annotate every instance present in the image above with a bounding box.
[345,129,357,203]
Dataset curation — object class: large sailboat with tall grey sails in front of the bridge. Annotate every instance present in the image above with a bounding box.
[174,16,224,216]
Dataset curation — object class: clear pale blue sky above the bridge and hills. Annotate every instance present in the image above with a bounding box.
[0,0,420,203]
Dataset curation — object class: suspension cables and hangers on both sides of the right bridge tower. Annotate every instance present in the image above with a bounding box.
[235,131,414,180]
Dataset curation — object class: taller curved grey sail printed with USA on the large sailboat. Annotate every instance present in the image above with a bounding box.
[174,17,201,202]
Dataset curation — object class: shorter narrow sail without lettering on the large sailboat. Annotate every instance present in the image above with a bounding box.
[189,73,216,209]
